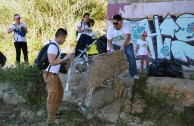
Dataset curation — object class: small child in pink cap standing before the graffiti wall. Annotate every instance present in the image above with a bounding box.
[135,31,151,72]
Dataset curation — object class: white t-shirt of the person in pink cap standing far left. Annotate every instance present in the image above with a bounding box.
[10,22,26,42]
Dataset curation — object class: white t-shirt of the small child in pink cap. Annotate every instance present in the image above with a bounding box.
[137,39,149,55]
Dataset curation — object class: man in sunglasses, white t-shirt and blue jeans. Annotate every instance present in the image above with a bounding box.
[107,14,139,79]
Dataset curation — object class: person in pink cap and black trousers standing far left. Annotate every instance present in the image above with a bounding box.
[7,14,28,63]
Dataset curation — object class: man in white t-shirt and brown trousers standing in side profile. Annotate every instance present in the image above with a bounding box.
[43,28,73,125]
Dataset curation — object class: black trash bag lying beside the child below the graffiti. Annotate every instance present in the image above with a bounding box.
[148,59,183,77]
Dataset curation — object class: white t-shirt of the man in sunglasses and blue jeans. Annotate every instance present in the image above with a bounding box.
[107,23,131,46]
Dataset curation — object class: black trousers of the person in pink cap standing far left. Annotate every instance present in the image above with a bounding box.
[14,42,28,62]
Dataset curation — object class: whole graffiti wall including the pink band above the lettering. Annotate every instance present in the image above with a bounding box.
[108,1,194,66]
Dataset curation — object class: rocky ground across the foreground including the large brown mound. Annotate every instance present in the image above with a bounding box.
[0,52,194,126]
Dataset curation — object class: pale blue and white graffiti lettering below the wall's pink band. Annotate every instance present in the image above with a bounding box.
[107,1,194,66]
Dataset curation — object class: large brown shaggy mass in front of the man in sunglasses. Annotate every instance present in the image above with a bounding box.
[88,51,128,87]
